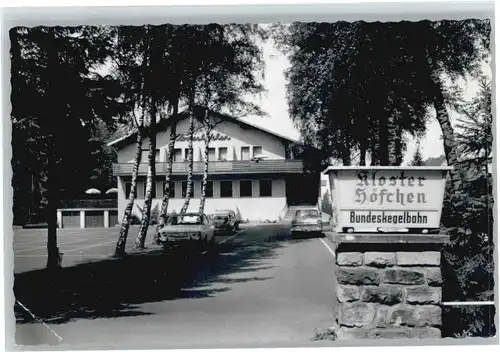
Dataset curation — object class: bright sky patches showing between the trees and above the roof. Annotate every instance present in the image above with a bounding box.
[240,34,491,164]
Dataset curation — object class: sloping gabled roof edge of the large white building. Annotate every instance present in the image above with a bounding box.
[108,107,300,148]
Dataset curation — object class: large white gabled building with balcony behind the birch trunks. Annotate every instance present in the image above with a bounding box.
[110,108,321,221]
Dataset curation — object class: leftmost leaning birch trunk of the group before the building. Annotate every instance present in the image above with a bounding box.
[115,130,143,257]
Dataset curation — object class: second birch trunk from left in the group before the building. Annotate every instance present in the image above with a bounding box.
[135,99,157,248]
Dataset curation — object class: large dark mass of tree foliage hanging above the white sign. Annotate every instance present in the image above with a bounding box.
[275,19,490,165]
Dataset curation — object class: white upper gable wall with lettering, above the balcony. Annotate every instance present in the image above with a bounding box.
[118,119,286,163]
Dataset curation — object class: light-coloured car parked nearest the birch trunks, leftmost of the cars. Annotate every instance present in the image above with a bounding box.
[156,213,215,248]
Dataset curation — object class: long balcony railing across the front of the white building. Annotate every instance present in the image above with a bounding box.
[113,160,303,176]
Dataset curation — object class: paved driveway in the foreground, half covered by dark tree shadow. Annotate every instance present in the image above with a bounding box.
[13,225,334,349]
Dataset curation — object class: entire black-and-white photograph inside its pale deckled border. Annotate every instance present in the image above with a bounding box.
[4,0,498,350]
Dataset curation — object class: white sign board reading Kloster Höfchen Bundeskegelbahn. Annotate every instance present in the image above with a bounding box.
[325,166,451,232]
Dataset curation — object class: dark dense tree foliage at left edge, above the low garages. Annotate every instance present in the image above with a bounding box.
[10,27,120,223]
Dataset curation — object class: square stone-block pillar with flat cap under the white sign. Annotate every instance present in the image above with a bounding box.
[332,234,448,339]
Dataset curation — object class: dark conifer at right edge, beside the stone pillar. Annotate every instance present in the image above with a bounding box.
[442,79,494,308]
